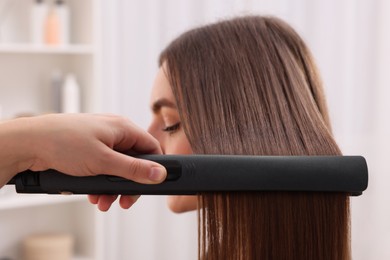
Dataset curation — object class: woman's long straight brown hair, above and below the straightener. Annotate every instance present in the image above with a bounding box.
[160,16,350,259]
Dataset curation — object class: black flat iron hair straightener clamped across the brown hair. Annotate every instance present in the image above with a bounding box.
[8,155,368,196]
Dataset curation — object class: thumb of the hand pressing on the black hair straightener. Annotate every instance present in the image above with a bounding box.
[99,148,167,184]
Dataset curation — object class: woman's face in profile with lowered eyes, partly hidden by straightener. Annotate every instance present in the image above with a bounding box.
[148,66,197,212]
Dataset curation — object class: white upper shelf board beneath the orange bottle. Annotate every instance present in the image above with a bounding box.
[0,43,94,55]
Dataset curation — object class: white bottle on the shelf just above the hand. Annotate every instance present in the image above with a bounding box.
[61,73,81,113]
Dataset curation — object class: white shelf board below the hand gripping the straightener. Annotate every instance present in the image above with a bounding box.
[0,194,87,211]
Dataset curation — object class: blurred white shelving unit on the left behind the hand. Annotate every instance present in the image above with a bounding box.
[0,0,104,260]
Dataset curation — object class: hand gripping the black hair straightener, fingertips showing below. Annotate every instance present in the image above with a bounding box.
[0,114,166,211]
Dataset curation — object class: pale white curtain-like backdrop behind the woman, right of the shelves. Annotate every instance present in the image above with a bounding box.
[97,0,390,259]
